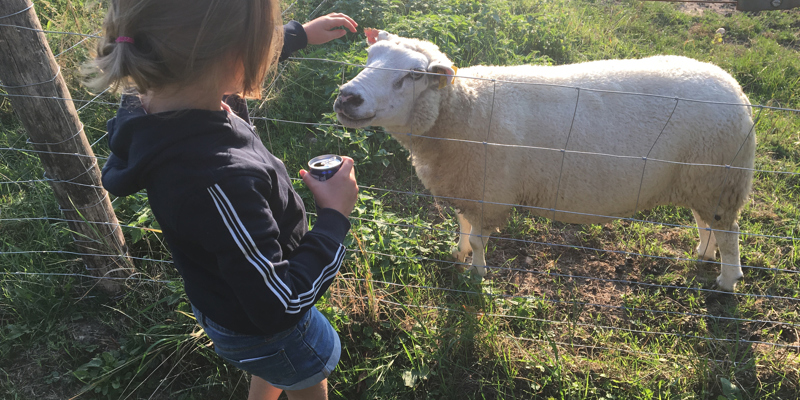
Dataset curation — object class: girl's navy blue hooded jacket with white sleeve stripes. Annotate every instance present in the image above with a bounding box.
[103,24,350,334]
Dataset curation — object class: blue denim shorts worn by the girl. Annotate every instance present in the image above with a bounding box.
[192,306,342,390]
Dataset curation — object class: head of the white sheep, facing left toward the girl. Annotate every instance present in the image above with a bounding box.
[333,29,455,133]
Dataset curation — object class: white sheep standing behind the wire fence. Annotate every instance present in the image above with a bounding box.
[334,30,755,291]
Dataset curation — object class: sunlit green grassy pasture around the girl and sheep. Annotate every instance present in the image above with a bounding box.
[0,0,800,400]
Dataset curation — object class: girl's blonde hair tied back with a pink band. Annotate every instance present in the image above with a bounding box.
[87,0,283,97]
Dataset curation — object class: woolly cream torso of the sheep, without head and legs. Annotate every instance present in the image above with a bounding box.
[416,57,755,226]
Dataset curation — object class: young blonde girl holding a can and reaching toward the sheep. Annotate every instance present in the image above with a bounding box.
[88,0,358,399]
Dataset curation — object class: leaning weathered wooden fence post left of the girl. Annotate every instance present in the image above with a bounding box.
[0,0,132,292]
